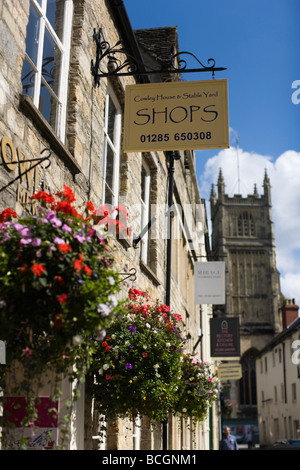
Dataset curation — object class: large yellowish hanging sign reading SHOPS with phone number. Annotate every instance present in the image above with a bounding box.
[123,79,229,152]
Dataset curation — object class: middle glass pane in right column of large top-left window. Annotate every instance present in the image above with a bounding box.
[42,28,61,95]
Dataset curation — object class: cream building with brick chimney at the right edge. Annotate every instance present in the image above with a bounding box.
[256,299,300,449]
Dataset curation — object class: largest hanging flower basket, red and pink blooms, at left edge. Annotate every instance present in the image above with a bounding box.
[0,186,123,374]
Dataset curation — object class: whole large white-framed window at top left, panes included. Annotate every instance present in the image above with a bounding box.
[22,0,73,142]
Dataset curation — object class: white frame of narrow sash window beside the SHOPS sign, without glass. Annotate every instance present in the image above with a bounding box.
[102,86,122,206]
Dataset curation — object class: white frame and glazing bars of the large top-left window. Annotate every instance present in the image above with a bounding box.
[25,0,73,143]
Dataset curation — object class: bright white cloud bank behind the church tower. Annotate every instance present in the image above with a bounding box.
[199,147,300,305]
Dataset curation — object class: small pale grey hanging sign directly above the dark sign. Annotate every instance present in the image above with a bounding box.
[194,261,225,305]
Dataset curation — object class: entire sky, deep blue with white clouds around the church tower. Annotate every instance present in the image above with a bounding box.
[124,0,300,305]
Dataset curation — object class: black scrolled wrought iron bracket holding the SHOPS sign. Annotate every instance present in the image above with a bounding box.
[91,28,226,87]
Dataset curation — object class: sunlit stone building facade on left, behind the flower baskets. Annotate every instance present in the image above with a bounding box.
[0,0,218,449]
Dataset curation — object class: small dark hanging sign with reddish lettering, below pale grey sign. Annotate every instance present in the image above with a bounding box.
[210,317,240,360]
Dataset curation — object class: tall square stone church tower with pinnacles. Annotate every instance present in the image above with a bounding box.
[210,170,281,418]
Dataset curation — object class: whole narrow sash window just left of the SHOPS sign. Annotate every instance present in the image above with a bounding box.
[102,89,122,206]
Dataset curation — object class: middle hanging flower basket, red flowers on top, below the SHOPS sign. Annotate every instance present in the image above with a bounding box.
[90,289,184,422]
